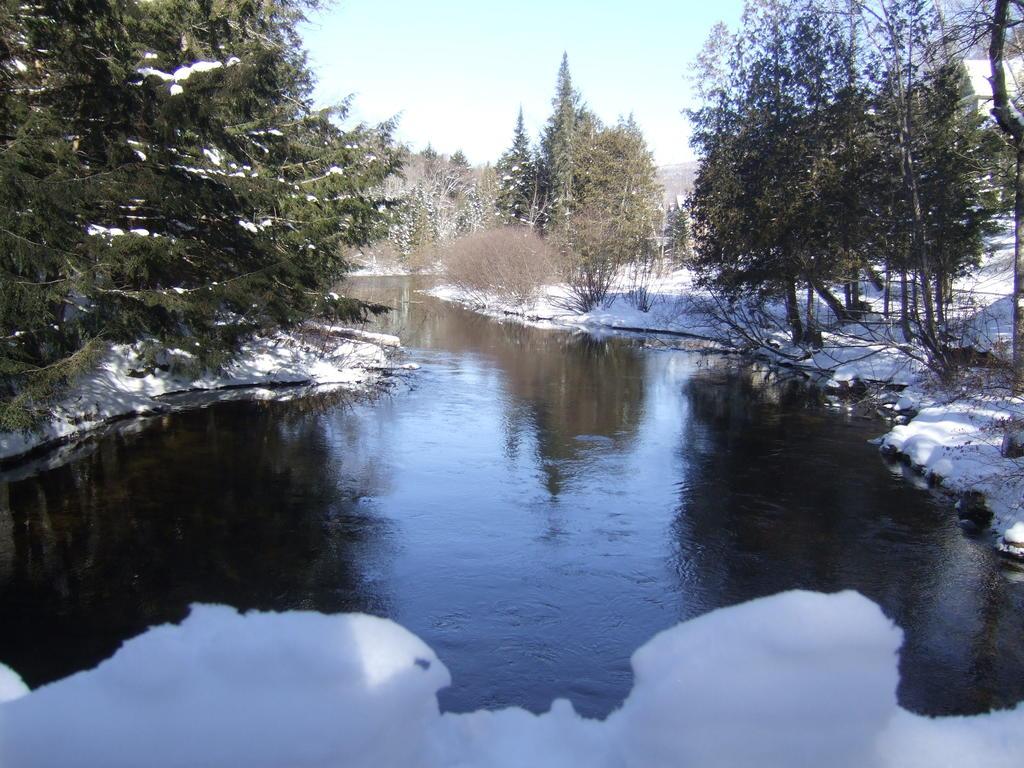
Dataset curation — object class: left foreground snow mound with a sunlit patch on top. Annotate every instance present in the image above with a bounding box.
[0,605,450,768]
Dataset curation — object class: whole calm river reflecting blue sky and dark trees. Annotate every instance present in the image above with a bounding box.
[0,278,1024,716]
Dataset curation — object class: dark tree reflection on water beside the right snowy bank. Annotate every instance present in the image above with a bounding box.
[674,369,1024,715]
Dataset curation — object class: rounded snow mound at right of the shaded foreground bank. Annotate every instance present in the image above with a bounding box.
[613,592,903,768]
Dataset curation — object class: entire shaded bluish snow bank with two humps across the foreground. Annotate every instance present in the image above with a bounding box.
[0,592,1024,768]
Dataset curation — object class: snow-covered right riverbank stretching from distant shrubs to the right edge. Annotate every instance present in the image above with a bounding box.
[430,257,1024,557]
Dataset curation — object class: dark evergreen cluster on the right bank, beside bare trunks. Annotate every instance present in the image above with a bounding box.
[690,0,1005,366]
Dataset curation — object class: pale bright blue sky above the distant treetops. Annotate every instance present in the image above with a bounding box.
[303,0,742,165]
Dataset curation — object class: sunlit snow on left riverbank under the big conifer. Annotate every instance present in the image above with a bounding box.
[0,326,399,460]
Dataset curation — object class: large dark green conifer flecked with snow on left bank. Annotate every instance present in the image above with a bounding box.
[0,0,399,430]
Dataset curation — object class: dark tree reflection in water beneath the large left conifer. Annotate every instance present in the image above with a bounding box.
[0,404,386,685]
